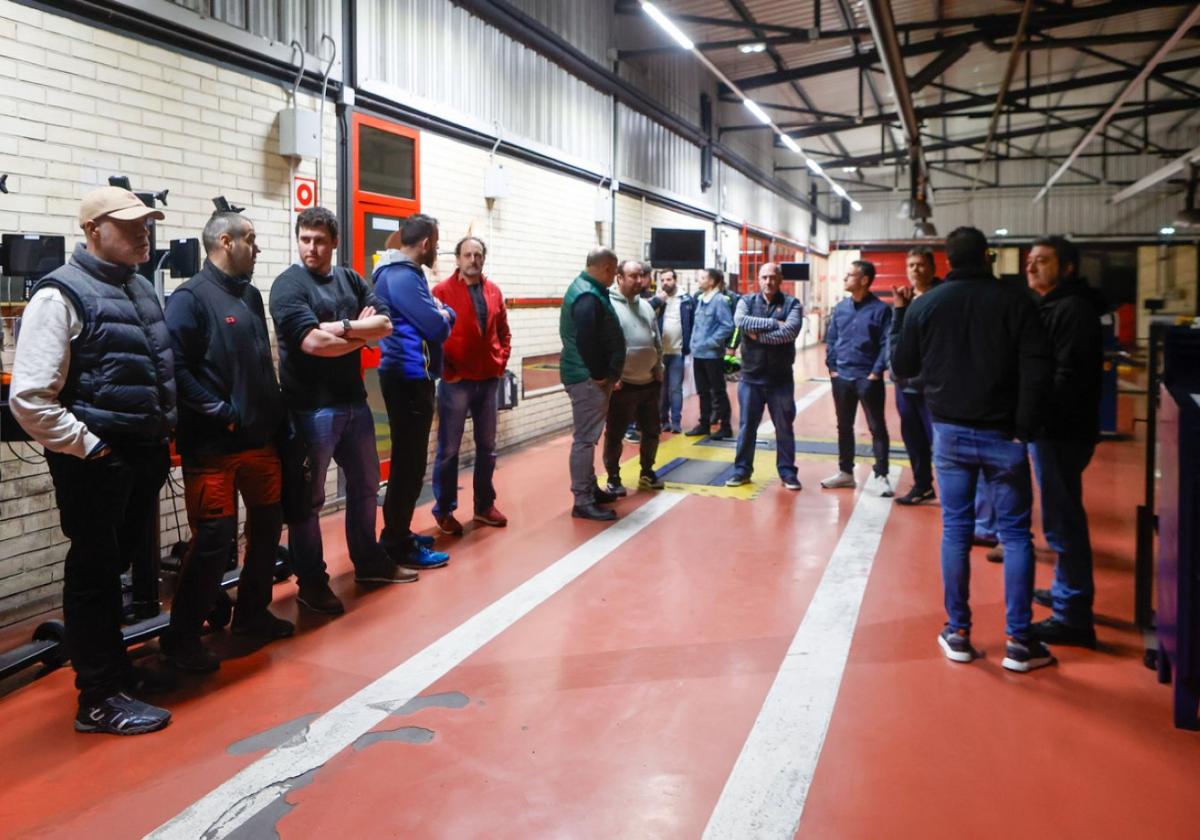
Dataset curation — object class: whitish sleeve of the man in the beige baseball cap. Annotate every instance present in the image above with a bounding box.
[8,287,101,458]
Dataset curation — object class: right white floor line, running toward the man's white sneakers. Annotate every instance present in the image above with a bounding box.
[704,467,900,840]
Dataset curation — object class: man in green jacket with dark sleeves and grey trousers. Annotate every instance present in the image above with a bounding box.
[558,247,625,521]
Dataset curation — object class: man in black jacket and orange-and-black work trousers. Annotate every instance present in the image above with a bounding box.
[162,212,294,672]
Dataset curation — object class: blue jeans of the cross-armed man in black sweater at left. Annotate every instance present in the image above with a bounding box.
[288,400,388,586]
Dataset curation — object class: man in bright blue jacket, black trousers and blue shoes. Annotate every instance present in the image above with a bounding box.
[373,214,455,569]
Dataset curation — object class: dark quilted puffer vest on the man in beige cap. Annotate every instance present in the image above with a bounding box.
[40,245,175,445]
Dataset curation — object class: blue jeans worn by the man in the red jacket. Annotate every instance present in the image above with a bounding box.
[433,379,499,517]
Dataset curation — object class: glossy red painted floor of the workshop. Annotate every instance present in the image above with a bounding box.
[0,353,1200,839]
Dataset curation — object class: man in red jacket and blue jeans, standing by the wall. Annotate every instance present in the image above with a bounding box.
[433,236,512,536]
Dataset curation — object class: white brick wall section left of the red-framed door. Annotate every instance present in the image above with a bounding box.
[0,0,337,625]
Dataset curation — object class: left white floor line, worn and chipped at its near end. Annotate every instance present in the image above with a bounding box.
[146,493,688,840]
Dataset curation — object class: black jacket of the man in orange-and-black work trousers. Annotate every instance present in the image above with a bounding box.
[167,260,283,456]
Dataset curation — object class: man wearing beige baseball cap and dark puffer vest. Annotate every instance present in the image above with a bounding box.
[11,187,175,734]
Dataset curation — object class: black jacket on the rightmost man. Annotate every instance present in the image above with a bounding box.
[1038,280,1108,442]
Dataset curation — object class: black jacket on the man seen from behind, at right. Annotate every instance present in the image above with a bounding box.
[892,269,1054,440]
